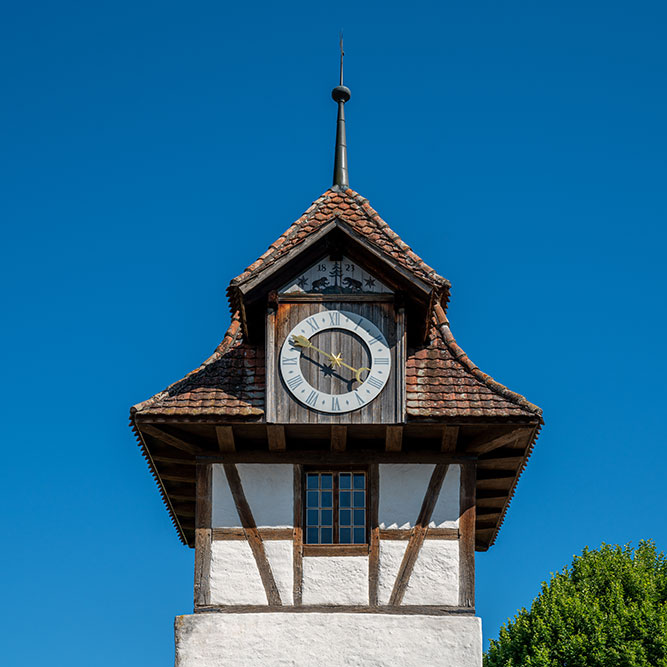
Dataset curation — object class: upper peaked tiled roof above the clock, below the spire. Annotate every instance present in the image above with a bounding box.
[227,186,450,311]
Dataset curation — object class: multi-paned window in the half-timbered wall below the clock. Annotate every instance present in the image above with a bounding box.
[304,470,368,544]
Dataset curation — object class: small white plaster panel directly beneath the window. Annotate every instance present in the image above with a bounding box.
[302,556,368,605]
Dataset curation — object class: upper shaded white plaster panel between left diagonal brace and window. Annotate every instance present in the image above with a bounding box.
[237,463,294,528]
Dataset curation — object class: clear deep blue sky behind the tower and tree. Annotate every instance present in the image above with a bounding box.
[0,0,667,667]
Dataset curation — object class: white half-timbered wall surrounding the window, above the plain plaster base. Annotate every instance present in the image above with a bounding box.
[201,464,471,607]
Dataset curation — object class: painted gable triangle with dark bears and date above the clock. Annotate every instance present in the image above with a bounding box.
[280,257,391,294]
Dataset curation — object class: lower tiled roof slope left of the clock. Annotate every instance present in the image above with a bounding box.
[132,313,265,417]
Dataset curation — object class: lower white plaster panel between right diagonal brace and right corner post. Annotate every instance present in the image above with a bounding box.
[403,540,459,606]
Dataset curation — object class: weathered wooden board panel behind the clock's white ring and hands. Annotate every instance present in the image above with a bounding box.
[266,301,405,424]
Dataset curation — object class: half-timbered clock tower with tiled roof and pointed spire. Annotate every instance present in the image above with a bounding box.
[131,58,542,667]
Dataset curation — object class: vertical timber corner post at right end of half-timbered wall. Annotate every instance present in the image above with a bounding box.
[459,463,477,607]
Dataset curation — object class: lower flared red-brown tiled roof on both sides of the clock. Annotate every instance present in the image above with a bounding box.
[133,305,542,418]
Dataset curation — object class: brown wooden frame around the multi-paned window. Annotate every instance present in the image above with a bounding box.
[299,465,376,556]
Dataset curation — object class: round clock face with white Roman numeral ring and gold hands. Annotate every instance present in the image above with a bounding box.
[280,310,391,414]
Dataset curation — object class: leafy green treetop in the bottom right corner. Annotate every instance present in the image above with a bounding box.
[484,541,667,667]
